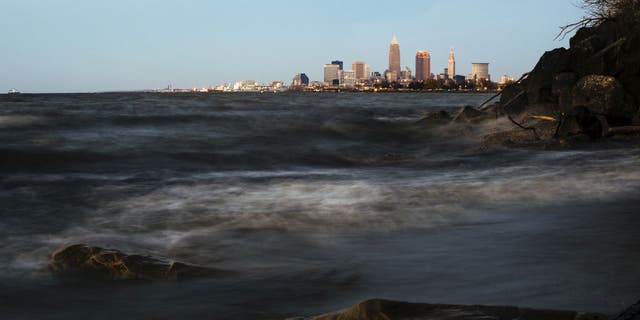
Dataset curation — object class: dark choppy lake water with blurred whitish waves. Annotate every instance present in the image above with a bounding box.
[0,94,640,319]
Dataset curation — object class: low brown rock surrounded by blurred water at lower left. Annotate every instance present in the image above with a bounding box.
[49,244,219,280]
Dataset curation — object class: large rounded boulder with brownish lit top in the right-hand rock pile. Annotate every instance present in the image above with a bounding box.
[572,75,637,124]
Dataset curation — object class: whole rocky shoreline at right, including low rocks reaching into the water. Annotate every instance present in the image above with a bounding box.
[420,9,640,148]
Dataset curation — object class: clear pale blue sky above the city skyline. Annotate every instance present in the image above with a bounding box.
[0,0,583,92]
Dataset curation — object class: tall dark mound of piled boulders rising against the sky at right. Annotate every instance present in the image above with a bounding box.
[500,14,640,143]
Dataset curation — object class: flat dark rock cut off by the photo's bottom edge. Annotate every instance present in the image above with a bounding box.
[297,300,608,320]
